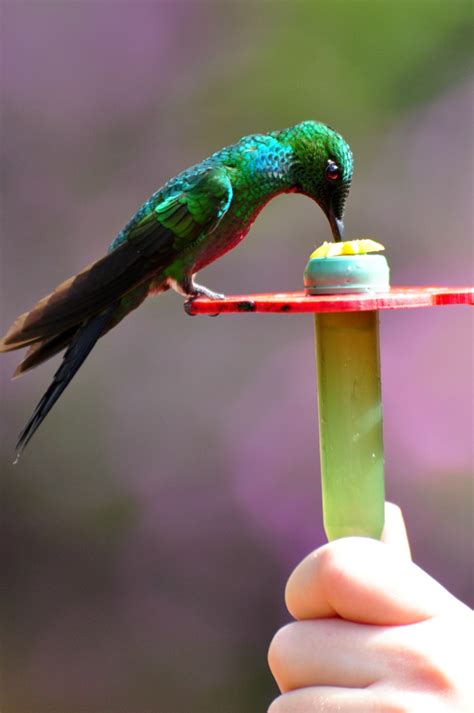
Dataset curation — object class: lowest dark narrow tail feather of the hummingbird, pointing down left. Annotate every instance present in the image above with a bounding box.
[15,303,117,463]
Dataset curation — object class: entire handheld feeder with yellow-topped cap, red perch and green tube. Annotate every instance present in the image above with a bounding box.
[188,240,474,540]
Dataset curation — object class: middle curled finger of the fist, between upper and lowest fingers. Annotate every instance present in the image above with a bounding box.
[268,619,391,692]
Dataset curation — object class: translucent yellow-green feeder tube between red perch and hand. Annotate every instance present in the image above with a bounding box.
[315,311,385,540]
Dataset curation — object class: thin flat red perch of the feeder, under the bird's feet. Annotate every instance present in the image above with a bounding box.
[188,287,474,315]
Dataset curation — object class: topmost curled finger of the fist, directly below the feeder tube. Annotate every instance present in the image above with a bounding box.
[285,537,460,625]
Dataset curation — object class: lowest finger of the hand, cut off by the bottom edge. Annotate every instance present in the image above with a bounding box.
[268,686,394,713]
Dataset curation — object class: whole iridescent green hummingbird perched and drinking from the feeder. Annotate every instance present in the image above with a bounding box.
[0,120,353,462]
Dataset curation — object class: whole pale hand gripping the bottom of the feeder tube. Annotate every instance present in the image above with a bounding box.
[268,503,474,713]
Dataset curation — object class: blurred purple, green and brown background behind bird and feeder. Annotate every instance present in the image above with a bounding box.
[0,0,474,713]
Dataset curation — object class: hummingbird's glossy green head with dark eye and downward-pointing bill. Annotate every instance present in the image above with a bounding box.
[278,121,353,241]
